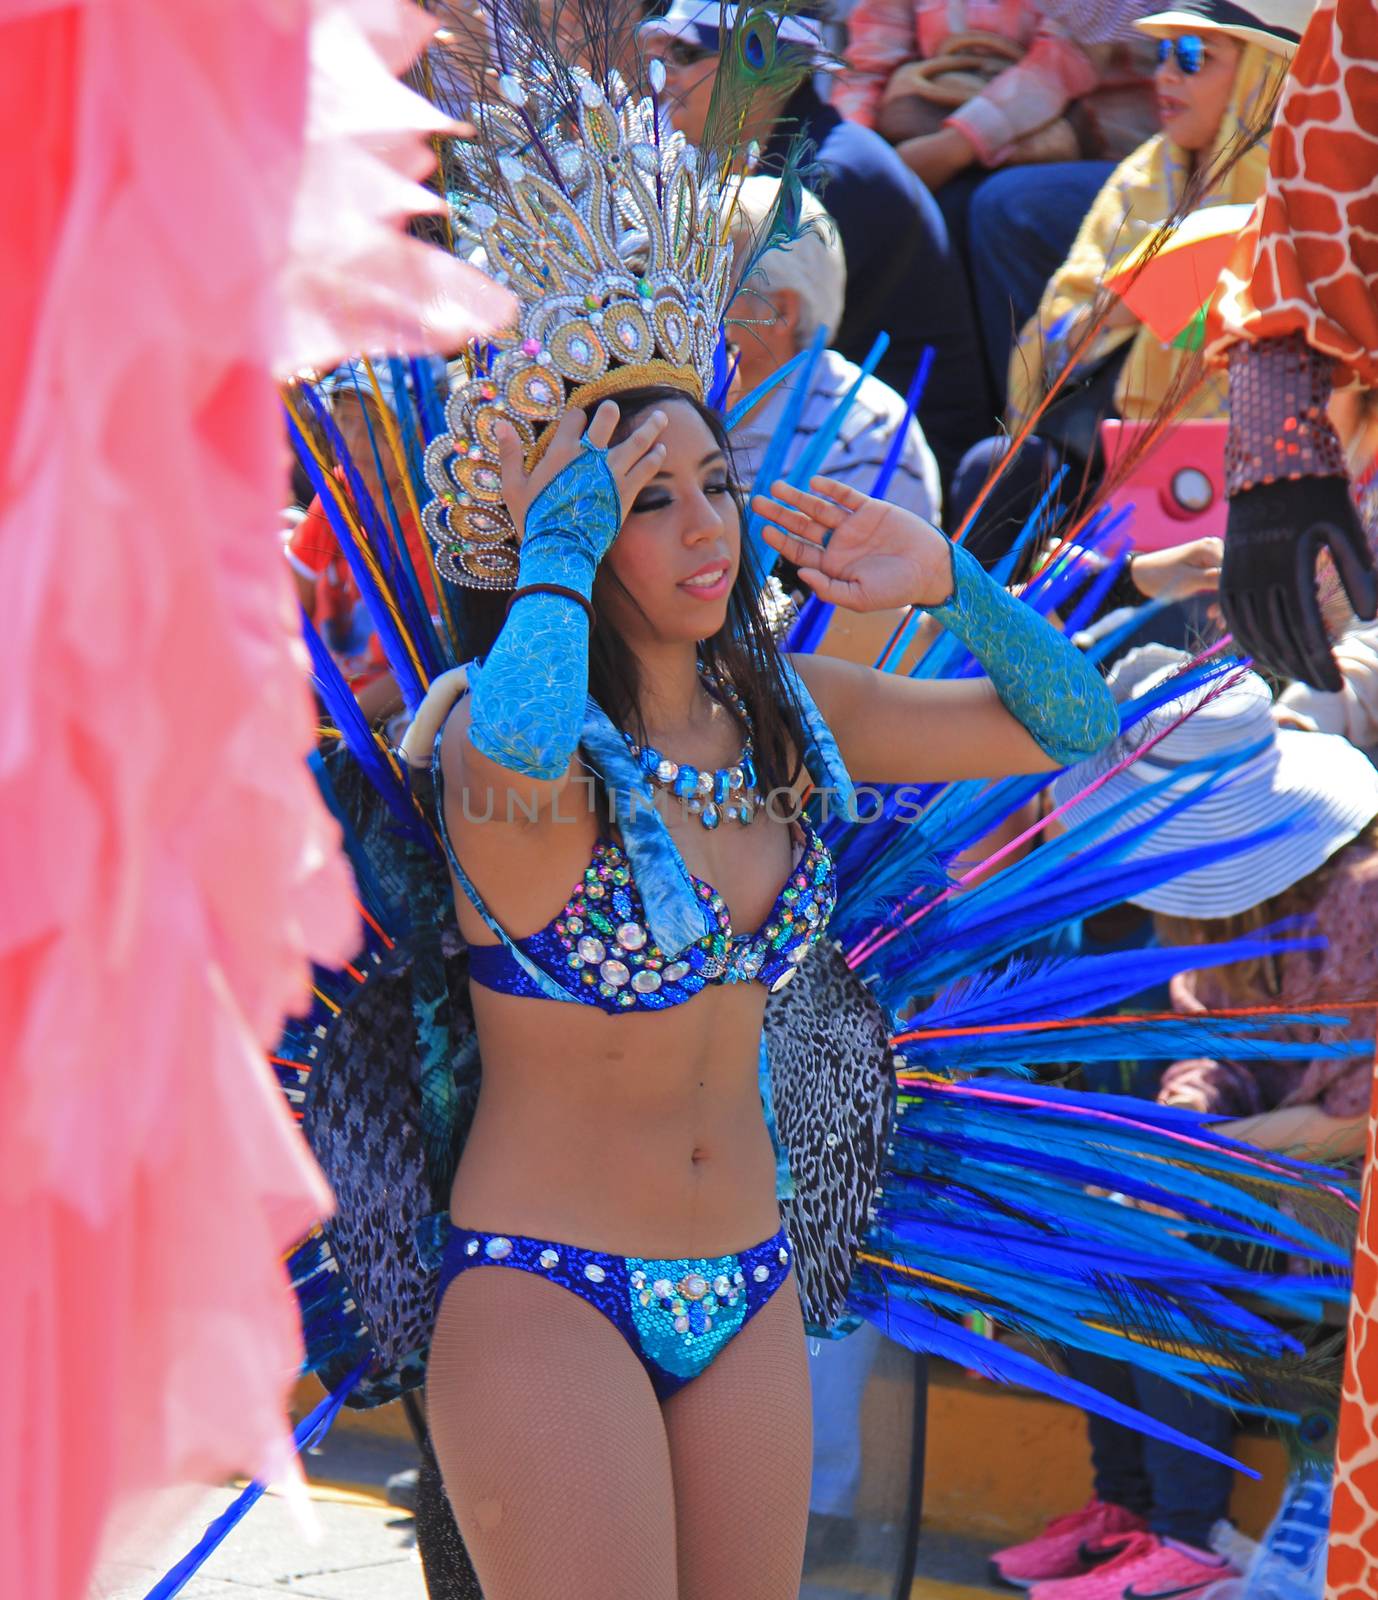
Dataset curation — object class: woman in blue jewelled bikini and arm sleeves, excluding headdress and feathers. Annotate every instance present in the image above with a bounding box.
[427,371,1114,1600]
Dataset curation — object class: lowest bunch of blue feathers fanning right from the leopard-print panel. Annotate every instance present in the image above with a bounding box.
[853,1074,1352,1432]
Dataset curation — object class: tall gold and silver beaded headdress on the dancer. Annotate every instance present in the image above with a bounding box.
[423,61,733,589]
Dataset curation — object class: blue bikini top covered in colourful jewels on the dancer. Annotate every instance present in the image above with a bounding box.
[469,819,837,1011]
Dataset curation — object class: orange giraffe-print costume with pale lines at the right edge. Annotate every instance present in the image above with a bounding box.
[1213,0,1378,1600]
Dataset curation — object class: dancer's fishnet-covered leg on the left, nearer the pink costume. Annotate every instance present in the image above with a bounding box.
[426,1267,675,1600]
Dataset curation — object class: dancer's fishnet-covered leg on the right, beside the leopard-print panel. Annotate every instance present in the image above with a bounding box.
[664,1280,813,1600]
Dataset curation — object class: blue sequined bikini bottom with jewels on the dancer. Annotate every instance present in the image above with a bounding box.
[435,1227,791,1400]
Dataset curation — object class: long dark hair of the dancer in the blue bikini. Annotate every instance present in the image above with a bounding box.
[451,384,807,792]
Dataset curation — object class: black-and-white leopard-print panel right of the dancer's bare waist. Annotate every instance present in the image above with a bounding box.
[765,942,895,1333]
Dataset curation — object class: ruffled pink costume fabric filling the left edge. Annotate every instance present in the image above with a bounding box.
[0,0,506,1600]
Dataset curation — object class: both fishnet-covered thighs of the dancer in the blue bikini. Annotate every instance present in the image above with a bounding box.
[426,1269,811,1600]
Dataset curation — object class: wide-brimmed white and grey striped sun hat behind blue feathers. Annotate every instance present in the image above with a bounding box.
[1053,645,1378,917]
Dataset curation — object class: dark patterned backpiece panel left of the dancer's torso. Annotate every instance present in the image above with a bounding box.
[301,746,480,1408]
